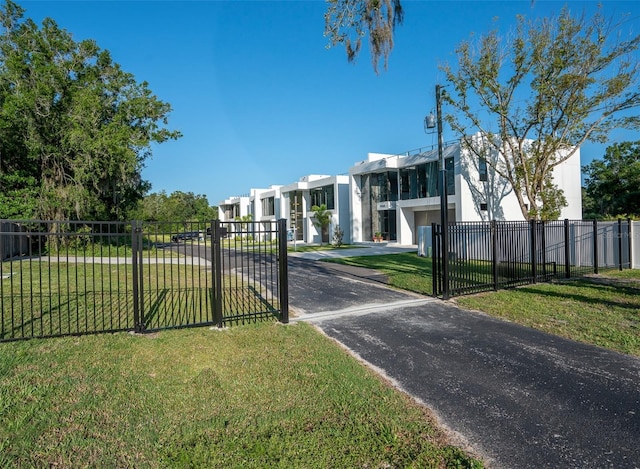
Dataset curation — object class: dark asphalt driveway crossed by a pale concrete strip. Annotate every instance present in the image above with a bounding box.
[289,247,640,468]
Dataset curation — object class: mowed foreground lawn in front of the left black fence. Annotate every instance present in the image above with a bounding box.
[0,323,482,468]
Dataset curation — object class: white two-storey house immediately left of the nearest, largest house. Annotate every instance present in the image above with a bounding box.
[280,174,351,243]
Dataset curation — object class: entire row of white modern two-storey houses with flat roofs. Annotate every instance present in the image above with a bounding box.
[219,136,582,245]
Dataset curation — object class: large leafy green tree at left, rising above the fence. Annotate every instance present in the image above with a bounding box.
[0,0,180,220]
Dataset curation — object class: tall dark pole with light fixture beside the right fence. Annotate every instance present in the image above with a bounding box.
[424,85,449,300]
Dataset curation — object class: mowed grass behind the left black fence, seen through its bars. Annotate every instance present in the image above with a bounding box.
[0,259,280,340]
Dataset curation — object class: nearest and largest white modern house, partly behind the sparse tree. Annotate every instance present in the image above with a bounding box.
[349,138,582,245]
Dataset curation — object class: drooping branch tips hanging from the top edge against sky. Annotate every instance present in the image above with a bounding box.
[324,0,404,73]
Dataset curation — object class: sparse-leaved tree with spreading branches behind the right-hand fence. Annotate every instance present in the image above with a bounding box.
[443,8,640,219]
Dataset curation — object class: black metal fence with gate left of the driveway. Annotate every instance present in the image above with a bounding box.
[0,220,288,341]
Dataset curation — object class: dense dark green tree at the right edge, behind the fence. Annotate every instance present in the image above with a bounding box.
[583,141,640,218]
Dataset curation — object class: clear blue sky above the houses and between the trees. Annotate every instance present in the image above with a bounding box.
[18,0,640,205]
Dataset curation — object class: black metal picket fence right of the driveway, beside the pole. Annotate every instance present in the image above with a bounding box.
[431,220,632,298]
